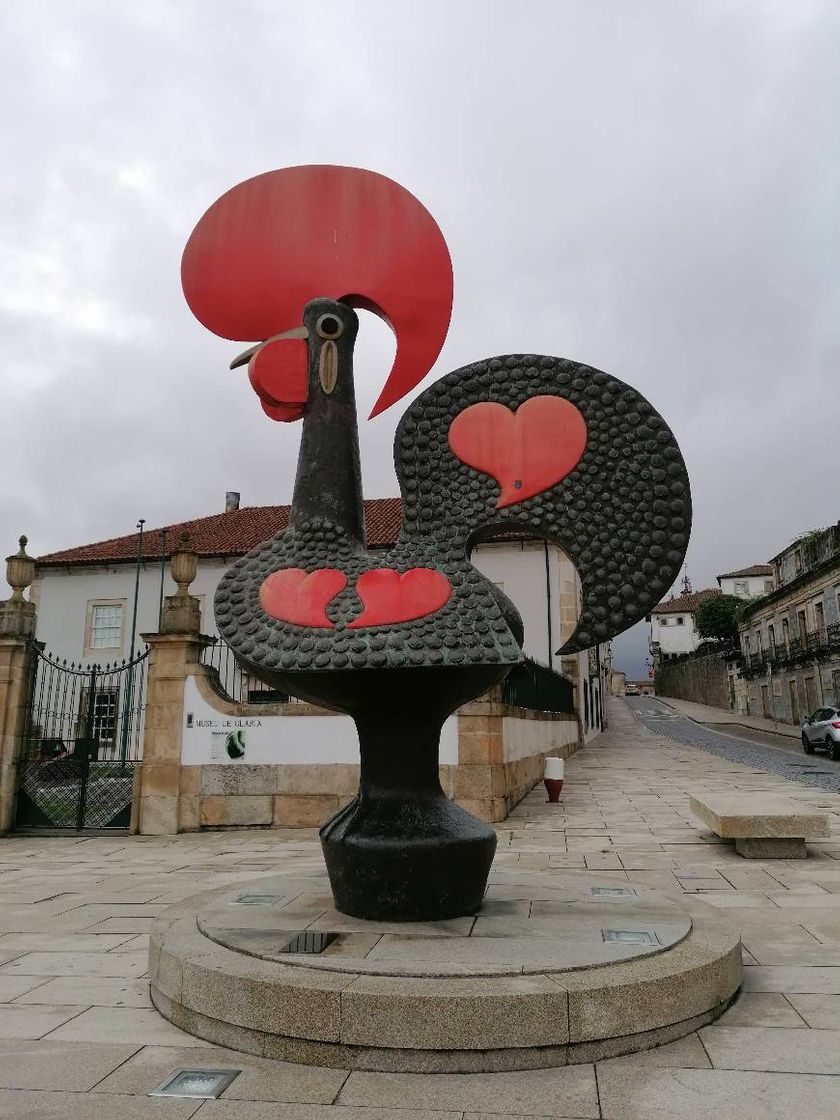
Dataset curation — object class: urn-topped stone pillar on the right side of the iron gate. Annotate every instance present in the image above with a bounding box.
[136,533,212,836]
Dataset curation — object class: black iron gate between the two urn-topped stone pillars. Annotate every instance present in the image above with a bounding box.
[17,648,149,830]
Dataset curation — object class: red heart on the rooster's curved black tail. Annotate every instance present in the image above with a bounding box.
[449,396,587,510]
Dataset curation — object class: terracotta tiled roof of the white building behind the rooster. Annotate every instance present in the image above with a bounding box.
[37,497,402,568]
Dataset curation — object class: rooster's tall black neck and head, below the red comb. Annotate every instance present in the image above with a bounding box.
[290,300,364,544]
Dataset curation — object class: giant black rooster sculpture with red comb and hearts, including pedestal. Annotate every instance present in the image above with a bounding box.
[183,167,691,921]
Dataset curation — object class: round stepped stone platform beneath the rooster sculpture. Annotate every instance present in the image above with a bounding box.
[149,872,741,1072]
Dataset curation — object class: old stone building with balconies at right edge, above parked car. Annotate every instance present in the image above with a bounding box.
[730,523,840,725]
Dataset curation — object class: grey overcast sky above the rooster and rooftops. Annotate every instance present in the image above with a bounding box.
[0,0,840,675]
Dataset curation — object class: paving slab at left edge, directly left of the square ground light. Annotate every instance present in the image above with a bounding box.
[0,1039,140,1092]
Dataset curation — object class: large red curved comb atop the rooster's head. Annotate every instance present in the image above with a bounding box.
[181,165,452,417]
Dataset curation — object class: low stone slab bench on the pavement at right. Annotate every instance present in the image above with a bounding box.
[689,793,829,859]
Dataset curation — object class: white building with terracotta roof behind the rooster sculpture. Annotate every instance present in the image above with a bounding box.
[31,495,608,737]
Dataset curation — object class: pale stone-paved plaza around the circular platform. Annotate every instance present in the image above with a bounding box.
[0,701,840,1120]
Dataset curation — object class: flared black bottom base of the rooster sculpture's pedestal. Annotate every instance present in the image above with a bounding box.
[320,792,496,922]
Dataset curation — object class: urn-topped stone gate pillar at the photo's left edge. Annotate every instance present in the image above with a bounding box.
[0,536,36,833]
